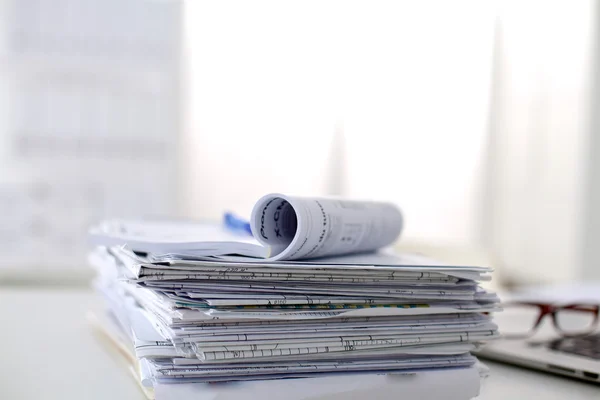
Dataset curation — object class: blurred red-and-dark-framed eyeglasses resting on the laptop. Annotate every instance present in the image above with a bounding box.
[494,302,600,339]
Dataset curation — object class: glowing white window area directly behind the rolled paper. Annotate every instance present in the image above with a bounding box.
[185,1,494,244]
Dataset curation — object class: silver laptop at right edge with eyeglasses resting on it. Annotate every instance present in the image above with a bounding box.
[475,286,600,384]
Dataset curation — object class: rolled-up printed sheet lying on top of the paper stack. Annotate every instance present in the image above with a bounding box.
[250,194,403,261]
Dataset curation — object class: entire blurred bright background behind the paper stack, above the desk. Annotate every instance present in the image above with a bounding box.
[0,0,600,284]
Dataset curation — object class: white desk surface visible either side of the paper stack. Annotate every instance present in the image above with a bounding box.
[0,287,600,400]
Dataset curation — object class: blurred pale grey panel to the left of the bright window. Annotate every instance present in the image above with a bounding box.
[0,0,182,283]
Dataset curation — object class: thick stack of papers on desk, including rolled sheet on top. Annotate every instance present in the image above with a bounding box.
[90,195,498,400]
